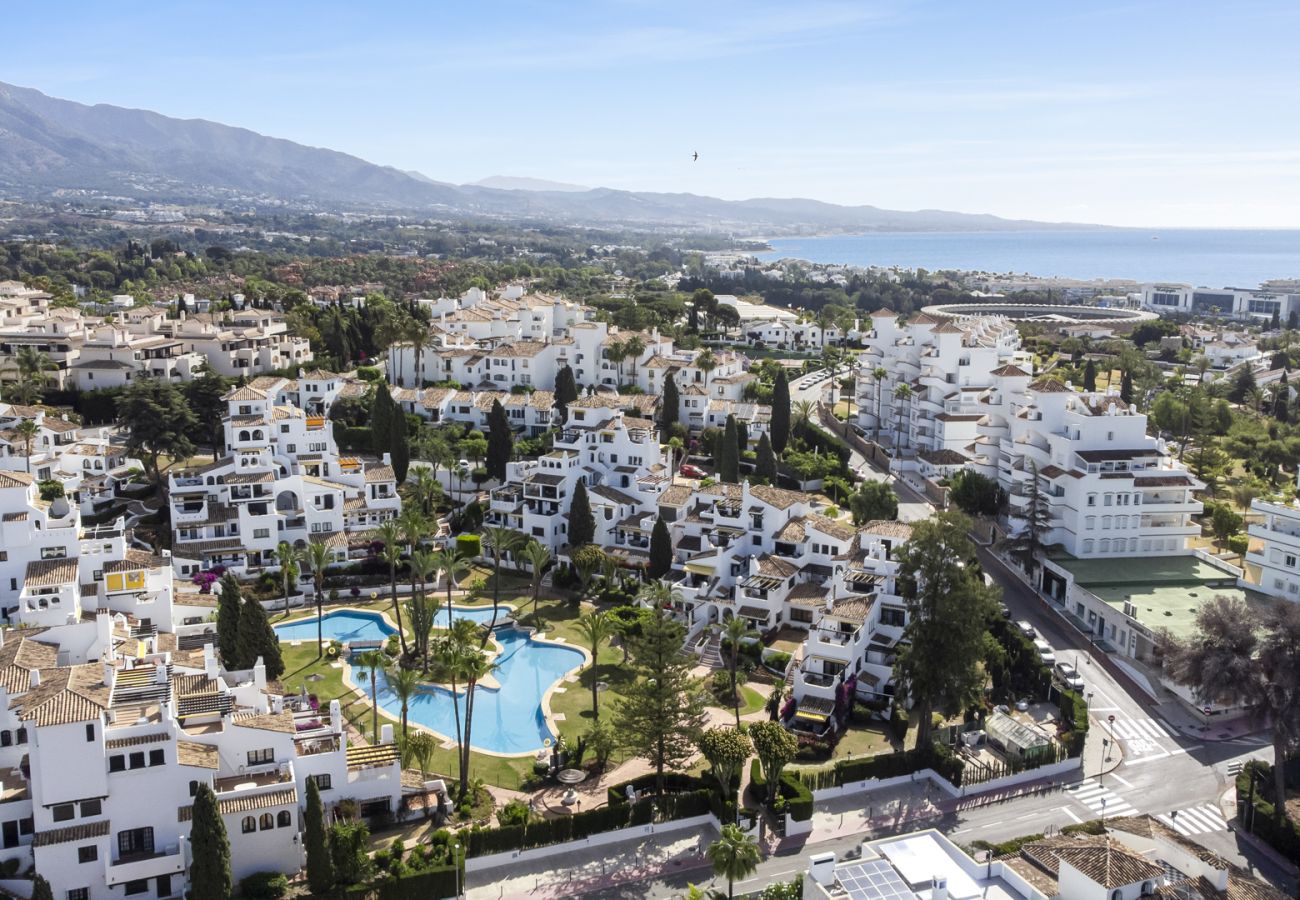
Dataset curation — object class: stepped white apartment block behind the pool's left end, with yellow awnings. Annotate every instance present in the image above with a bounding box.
[168,385,402,576]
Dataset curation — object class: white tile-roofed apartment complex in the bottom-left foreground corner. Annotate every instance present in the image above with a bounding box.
[0,615,402,900]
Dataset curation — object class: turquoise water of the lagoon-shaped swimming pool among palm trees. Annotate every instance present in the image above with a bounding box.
[276,606,584,753]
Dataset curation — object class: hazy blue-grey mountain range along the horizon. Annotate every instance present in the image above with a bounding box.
[0,82,1078,234]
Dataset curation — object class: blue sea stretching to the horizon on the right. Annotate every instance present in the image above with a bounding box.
[757,228,1300,287]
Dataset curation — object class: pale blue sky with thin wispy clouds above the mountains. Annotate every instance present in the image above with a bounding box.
[0,0,1300,228]
